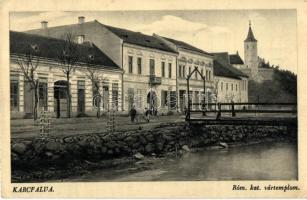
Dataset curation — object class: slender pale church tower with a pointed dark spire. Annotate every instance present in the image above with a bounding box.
[244,21,258,79]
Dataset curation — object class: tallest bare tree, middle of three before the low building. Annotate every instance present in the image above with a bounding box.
[58,33,79,118]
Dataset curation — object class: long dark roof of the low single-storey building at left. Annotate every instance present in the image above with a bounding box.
[10,31,120,69]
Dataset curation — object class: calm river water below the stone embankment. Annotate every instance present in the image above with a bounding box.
[63,141,298,181]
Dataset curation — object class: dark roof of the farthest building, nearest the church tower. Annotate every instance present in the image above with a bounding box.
[212,52,248,78]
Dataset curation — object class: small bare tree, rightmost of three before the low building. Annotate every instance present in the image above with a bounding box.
[86,55,103,118]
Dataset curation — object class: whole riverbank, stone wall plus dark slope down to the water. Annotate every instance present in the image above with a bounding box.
[11,123,296,182]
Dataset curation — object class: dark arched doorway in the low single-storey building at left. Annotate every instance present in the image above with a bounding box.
[54,81,67,118]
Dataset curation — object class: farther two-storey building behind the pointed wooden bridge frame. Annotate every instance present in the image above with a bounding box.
[154,34,214,111]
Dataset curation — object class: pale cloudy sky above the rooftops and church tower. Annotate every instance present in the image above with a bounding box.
[10,9,297,73]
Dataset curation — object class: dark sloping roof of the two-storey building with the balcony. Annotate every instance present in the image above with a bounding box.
[101,24,177,53]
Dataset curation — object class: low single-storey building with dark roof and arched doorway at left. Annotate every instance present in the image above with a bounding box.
[10,31,123,118]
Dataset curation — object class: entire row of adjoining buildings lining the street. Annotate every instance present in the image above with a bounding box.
[10,17,251,118]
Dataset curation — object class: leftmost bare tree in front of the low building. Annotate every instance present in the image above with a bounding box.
[17,44,40,120]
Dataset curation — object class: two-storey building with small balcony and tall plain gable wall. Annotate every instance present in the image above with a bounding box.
[27,17,178,111]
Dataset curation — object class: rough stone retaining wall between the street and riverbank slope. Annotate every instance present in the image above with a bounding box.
[11,123,296,167]
